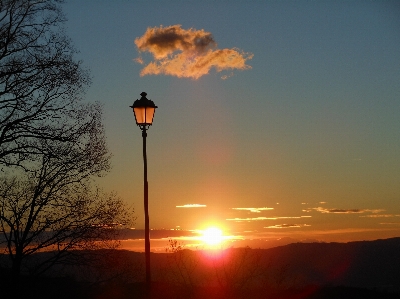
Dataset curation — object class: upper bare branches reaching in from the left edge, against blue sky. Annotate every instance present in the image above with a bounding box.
[0,0,91,168]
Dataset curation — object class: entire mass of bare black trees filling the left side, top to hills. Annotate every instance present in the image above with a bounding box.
[0,0,132,275]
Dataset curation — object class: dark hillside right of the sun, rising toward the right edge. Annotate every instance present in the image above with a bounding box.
[264,238,400,292]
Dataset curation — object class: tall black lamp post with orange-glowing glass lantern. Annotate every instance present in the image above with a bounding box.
[129,92,157,290]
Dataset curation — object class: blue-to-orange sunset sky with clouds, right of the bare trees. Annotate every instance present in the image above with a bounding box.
[63,0,400,247]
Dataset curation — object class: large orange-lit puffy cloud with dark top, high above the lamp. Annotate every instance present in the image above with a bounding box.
[135,25,253,79]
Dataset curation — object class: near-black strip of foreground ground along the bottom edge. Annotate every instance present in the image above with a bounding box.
[0,278,400,299]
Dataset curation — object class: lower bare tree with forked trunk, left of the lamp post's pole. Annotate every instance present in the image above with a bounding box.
[0,97,133,275]
